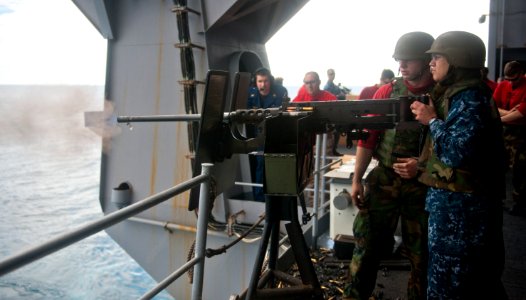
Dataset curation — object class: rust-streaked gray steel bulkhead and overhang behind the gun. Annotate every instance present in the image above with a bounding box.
[75,0,307,299]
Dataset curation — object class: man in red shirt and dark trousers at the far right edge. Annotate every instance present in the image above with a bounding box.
[493,61,526,216]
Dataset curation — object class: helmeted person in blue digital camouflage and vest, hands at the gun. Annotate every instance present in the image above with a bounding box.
[411,31,507,300]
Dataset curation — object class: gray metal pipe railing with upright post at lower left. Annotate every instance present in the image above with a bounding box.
[0,163,213,300]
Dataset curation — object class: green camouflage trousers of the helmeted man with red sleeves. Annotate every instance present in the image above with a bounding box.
[344,166,428,299]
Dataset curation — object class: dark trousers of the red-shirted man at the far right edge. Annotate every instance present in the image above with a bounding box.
[504,125,526,208]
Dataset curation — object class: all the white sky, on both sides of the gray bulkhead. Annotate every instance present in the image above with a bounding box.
[0,0,489,87]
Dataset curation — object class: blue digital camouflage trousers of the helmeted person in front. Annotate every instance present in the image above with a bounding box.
[427,188,507,300]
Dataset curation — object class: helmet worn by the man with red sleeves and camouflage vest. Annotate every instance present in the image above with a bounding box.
[393,31,435,61]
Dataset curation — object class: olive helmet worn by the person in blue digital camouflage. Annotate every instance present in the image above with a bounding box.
[426,31,486,69]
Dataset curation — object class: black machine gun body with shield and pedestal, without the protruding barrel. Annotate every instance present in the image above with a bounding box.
[189,71,432,299]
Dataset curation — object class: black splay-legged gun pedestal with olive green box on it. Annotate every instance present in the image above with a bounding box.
[246,116,323,299]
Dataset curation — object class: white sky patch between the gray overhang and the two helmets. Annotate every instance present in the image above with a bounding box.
[266,0,489,91]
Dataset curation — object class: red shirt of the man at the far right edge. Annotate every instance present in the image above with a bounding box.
[493,77,526,116]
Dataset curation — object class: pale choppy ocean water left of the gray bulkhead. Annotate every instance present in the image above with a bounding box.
[0,86,173,299]
